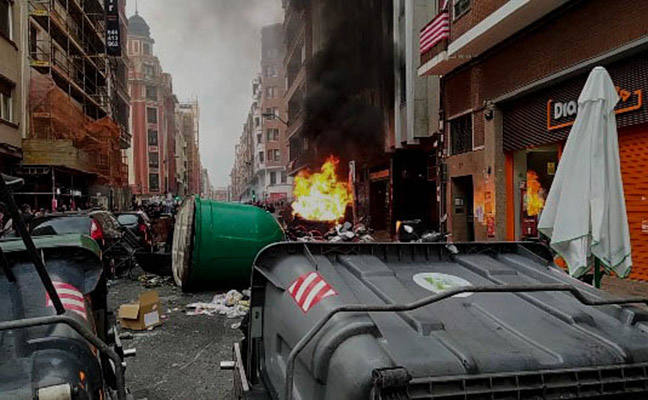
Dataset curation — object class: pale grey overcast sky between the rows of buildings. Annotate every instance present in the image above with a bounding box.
[127,0,283,186]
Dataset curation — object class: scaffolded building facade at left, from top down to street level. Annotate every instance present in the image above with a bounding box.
[21,0,131,209]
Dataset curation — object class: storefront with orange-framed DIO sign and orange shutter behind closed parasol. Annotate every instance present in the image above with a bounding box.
[499,52,648,280]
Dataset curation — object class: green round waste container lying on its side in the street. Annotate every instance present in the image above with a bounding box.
[173,196,284,290]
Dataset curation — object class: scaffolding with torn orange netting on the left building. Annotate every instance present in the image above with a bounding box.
[23,0,130,186]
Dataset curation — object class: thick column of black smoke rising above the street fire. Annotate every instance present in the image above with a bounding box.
[303,0,394,165]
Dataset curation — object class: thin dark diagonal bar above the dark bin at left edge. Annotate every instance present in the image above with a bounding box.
[0,174,65,314]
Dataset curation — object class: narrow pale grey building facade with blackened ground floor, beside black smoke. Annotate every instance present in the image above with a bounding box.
[388,0,440,231]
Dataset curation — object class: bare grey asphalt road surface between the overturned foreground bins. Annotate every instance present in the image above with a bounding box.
[109,272,242,400]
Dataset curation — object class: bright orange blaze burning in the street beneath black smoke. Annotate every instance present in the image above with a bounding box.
[292,156,353,222]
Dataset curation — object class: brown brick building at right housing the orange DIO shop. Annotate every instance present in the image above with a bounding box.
[419,0,648,279]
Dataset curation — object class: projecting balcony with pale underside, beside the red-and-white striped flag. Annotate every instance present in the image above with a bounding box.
[418,0,569,76]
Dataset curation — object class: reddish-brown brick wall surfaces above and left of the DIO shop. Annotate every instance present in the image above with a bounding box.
[442,0,648,240]
